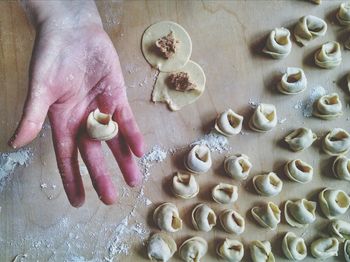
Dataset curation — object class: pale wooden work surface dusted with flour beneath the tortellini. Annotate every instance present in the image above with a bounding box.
[0,0,350,261]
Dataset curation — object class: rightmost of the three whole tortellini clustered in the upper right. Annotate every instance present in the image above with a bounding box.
[315,41,342,69]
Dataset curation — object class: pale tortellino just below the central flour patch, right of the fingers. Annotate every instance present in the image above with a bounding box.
[185,145,212,173]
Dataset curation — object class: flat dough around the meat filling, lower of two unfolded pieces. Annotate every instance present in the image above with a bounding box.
[152,61,206,111]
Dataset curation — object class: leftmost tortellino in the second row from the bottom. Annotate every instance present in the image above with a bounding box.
[153,203,182,232]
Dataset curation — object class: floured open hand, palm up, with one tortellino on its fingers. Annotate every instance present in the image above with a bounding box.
[9,0,144,207]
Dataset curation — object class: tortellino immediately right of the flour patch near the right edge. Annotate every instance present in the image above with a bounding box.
[312,93,343,120]
